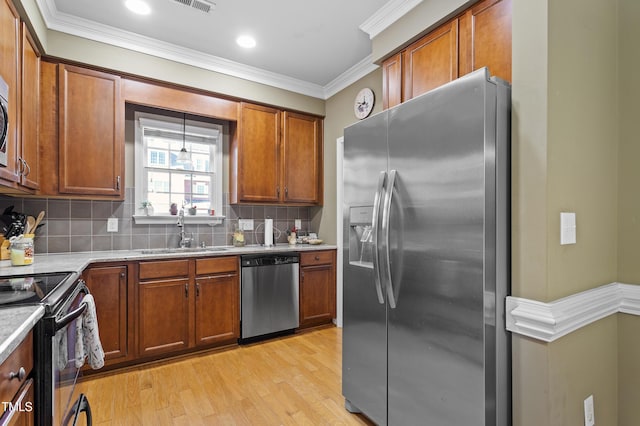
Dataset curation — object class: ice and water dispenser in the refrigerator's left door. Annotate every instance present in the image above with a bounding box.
[349,206,374,269]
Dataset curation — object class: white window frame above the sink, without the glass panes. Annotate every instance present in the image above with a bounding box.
[133,111,224,226]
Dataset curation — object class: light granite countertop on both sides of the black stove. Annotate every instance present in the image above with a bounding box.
[0,244,337,363]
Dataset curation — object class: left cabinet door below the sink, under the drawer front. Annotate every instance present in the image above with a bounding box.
[138,278,189,357]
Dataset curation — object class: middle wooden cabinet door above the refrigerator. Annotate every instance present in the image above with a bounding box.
[402,19,458,101]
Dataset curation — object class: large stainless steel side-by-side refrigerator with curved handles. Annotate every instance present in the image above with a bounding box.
[342,68,511,426]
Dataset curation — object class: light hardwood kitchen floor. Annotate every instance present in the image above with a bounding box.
[78,327,371,426]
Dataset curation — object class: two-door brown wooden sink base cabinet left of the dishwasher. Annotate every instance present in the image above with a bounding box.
[137,256,240,358]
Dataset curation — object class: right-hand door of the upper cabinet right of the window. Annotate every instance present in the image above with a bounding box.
[282,112,323,204]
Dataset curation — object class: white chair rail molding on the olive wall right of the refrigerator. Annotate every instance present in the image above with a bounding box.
[506,283,640,342]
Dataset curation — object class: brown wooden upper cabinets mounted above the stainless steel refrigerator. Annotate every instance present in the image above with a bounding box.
[382,0,512,108]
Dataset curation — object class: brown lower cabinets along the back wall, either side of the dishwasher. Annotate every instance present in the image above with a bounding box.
[83,250,336,367]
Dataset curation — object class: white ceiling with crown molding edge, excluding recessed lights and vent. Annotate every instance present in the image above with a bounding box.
[36,0,421,99]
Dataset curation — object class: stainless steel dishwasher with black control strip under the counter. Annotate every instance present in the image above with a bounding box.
[240,253,300,343]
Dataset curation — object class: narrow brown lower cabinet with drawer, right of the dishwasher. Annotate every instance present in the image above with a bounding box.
[300,250,336,328]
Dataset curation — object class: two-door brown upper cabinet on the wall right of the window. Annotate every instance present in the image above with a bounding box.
[230,103,323,205]
